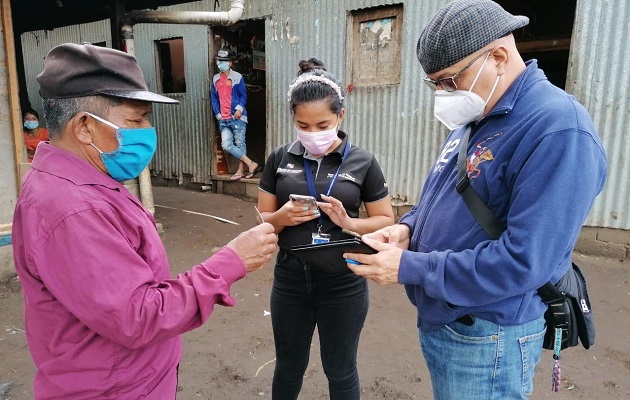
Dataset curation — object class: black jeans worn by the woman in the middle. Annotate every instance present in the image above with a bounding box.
[271,250,368,400]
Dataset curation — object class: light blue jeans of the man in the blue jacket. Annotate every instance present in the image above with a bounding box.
[420,318,545,400]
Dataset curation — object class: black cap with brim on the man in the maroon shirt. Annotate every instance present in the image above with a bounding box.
[37,43,179,104]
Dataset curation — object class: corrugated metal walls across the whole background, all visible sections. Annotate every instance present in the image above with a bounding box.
[18,0,630,229]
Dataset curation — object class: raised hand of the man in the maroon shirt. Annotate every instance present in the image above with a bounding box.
[227,222,278,272]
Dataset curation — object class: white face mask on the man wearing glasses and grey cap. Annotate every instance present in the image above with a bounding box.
[433,53,499,130]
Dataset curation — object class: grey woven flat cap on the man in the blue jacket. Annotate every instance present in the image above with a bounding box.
[416,0,529,74]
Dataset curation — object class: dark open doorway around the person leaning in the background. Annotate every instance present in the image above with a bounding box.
[210,19,267,177]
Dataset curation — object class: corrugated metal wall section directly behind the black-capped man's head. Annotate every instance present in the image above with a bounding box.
[21,20,112,115]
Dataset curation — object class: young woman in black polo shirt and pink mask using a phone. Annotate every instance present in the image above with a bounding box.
[258,58,394,400]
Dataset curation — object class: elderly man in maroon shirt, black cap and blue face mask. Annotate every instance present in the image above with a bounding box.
[13,44,276,399]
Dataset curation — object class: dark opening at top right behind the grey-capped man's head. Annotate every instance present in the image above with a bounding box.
[496,0,577,89]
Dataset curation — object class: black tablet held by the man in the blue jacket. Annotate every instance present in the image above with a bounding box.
[291,238,377,274]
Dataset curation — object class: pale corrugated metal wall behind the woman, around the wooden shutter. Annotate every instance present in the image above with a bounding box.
[167,0,447,204]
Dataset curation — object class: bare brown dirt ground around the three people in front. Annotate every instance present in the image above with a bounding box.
[0,187,630,400]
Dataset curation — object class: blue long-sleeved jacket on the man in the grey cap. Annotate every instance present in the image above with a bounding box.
[399,60,606,332]
